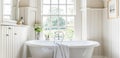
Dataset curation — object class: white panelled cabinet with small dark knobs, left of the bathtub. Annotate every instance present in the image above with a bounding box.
[0,26,28,58]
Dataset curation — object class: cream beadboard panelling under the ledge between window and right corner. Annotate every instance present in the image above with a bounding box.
[87,9,103,56]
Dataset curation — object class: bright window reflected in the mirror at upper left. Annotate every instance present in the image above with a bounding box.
[3,0,12,20]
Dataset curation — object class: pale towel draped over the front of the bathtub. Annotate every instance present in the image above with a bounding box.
[54,43,69,58]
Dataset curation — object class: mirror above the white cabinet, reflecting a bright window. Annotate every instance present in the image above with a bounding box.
[2,0,19,22]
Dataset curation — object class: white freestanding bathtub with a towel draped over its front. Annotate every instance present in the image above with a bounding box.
[26,40,99,58]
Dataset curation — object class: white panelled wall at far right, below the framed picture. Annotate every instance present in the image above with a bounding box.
[103,1,120,58]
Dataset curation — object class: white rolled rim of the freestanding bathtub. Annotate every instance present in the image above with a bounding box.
[25,40,100,48]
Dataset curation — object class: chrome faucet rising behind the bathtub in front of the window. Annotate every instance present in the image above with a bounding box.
[54,31,64,43]
